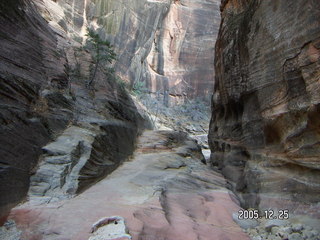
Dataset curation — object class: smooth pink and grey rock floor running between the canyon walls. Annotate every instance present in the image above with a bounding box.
[5,131,249,240]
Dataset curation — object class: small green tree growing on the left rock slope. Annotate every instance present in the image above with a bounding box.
[86,28,116,87]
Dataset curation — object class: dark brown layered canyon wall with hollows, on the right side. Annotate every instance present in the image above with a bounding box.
[209,0,320,216]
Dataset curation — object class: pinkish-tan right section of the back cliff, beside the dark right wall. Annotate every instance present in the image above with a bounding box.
[146,0,220,102]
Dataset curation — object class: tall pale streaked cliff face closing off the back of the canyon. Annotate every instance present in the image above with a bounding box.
[52,0,220,104]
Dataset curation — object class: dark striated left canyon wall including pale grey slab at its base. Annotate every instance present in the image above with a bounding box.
[0,0,146,220]
